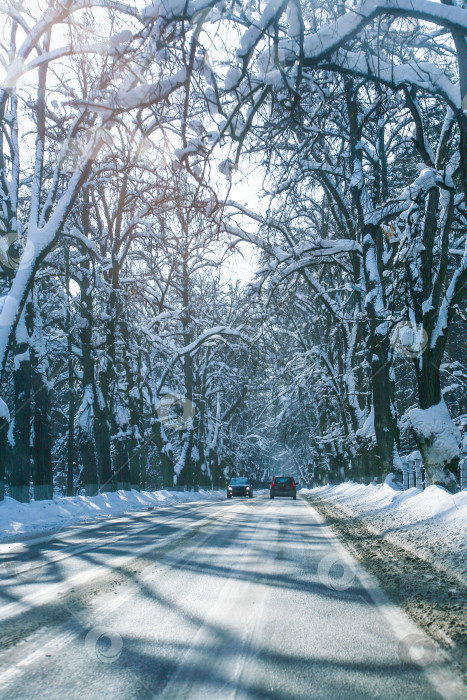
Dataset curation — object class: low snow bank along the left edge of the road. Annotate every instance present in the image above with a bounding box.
[0,491,225,542]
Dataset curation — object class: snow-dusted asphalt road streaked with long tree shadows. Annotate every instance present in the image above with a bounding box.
[0,497,466,700]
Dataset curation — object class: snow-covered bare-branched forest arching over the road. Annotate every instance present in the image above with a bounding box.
[0,0,467,502]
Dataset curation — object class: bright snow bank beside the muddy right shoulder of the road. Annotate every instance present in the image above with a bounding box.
[300,481,467,584]
